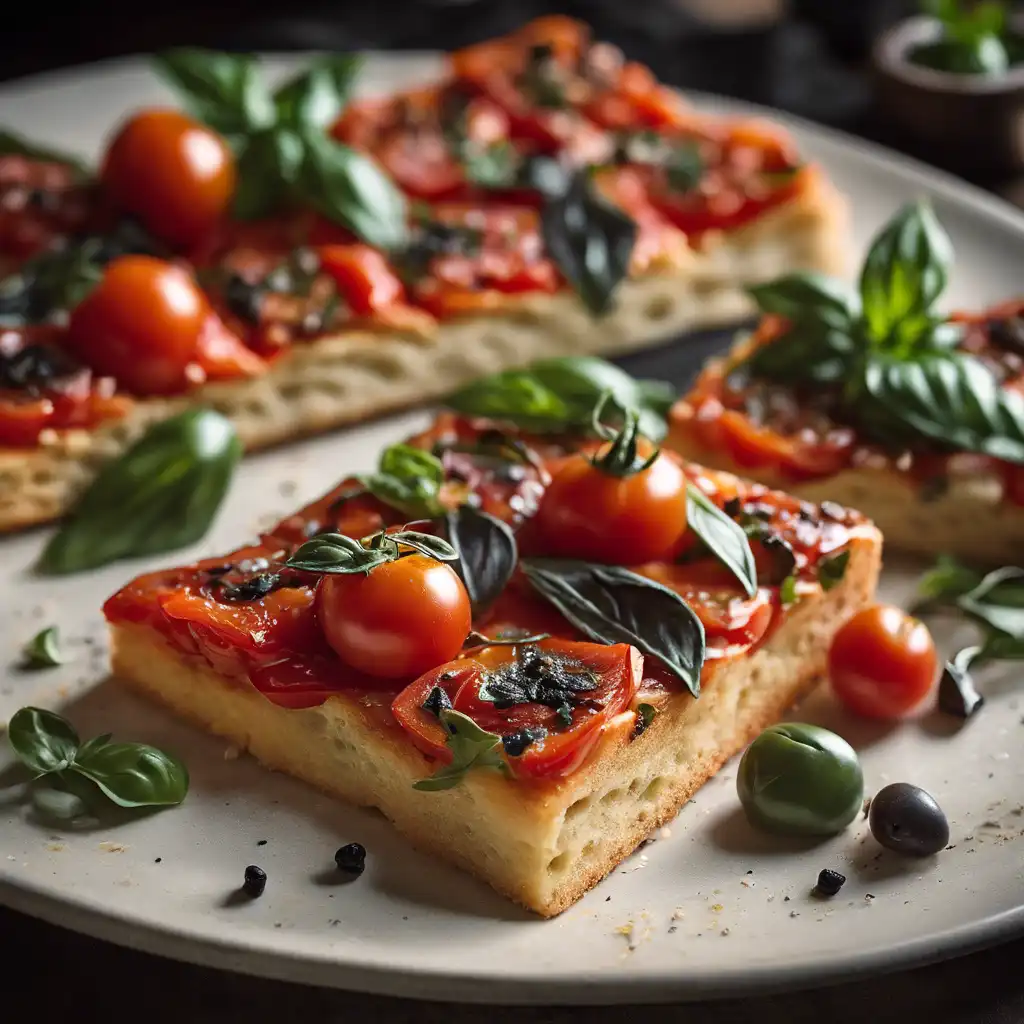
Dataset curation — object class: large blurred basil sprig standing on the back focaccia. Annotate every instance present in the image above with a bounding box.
[156,49,407,249]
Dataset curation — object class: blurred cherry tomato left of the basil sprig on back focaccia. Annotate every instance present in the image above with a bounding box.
[101,110,237,248]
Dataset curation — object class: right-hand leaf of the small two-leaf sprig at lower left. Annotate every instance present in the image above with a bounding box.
[74,743,188,807]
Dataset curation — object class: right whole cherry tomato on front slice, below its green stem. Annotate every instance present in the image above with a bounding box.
[536,453,686,565]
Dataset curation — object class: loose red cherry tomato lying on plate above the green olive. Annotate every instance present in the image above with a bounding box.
[828,604,939,718]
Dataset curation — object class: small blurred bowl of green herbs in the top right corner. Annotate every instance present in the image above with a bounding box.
[873,0,1024,173]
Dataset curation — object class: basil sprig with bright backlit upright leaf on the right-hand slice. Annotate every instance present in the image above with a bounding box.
[744,203,1024,463]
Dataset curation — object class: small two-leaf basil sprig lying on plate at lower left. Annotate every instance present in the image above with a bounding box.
[7,708,188,808]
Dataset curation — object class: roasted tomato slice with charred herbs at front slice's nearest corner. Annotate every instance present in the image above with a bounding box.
[391,639,643,778]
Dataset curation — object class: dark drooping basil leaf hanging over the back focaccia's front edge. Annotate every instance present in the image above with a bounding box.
[541,172,637,315]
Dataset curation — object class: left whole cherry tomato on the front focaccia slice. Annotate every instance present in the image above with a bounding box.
[317,555,471,679]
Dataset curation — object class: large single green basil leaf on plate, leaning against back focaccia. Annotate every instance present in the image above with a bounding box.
[38,409,242,573]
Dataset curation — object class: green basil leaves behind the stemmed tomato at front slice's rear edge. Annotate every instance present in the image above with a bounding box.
[445,355,675,441]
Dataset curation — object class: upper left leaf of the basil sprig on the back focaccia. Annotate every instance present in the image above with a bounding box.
[154,48,274,135]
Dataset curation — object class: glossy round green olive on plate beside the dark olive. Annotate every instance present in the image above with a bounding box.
[736,722,864,836]
